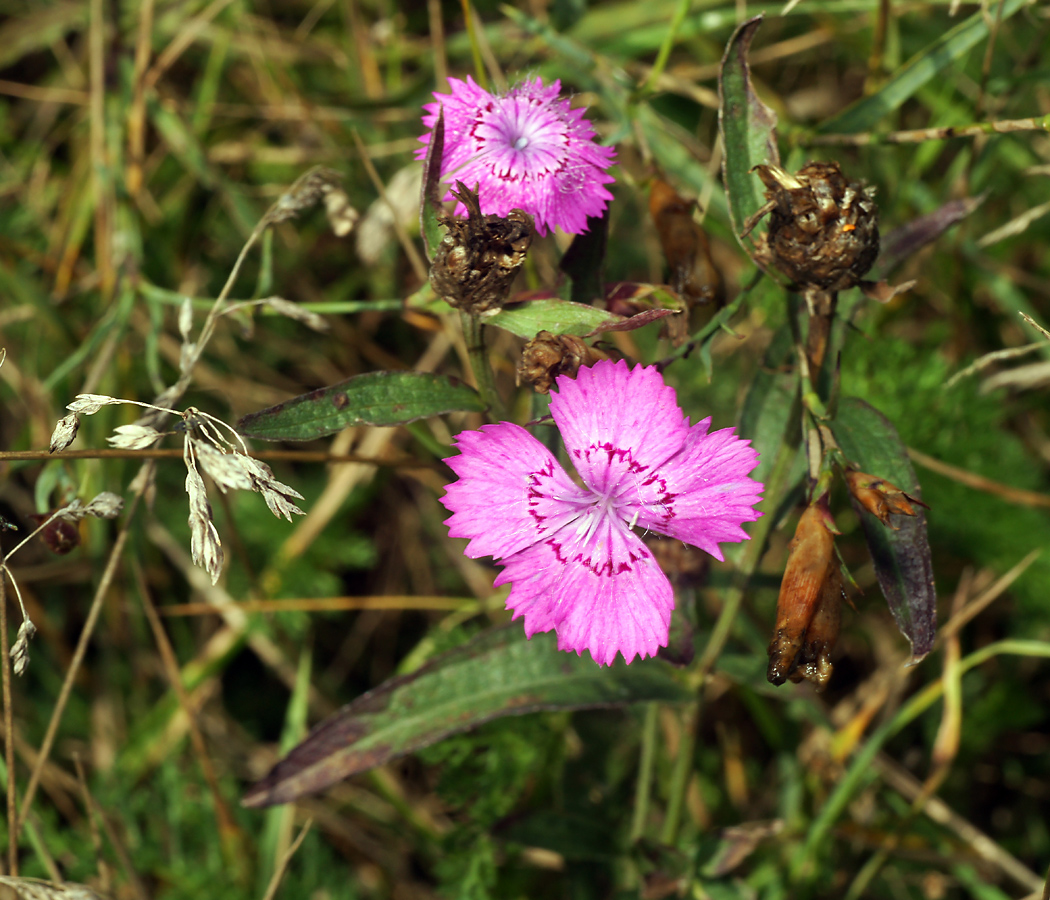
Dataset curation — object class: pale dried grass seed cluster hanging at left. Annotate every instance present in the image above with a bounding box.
[51,394,305,584]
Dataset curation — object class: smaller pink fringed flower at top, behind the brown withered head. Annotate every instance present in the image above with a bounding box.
[416,76,616,234]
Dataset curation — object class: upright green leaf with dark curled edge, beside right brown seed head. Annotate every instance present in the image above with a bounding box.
[718,16,780,253]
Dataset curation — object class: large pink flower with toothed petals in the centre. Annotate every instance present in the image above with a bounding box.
[442,360,762,665]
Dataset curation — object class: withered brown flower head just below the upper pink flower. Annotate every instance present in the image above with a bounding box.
[431,182,534,315]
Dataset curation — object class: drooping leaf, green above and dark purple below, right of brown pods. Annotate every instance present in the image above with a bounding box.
[832,397,937,663]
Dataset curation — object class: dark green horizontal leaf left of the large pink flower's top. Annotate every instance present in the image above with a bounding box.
[237,372,485,441]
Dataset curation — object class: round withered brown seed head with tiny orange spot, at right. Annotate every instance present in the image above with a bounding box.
[744,163,879,291]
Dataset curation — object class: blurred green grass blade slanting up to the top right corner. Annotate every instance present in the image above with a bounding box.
[817,0,1028,134]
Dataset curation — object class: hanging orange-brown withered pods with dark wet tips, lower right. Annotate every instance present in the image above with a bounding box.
[765,502,844,691]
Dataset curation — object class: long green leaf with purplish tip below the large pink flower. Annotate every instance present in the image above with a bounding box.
[244,624,690,807]
